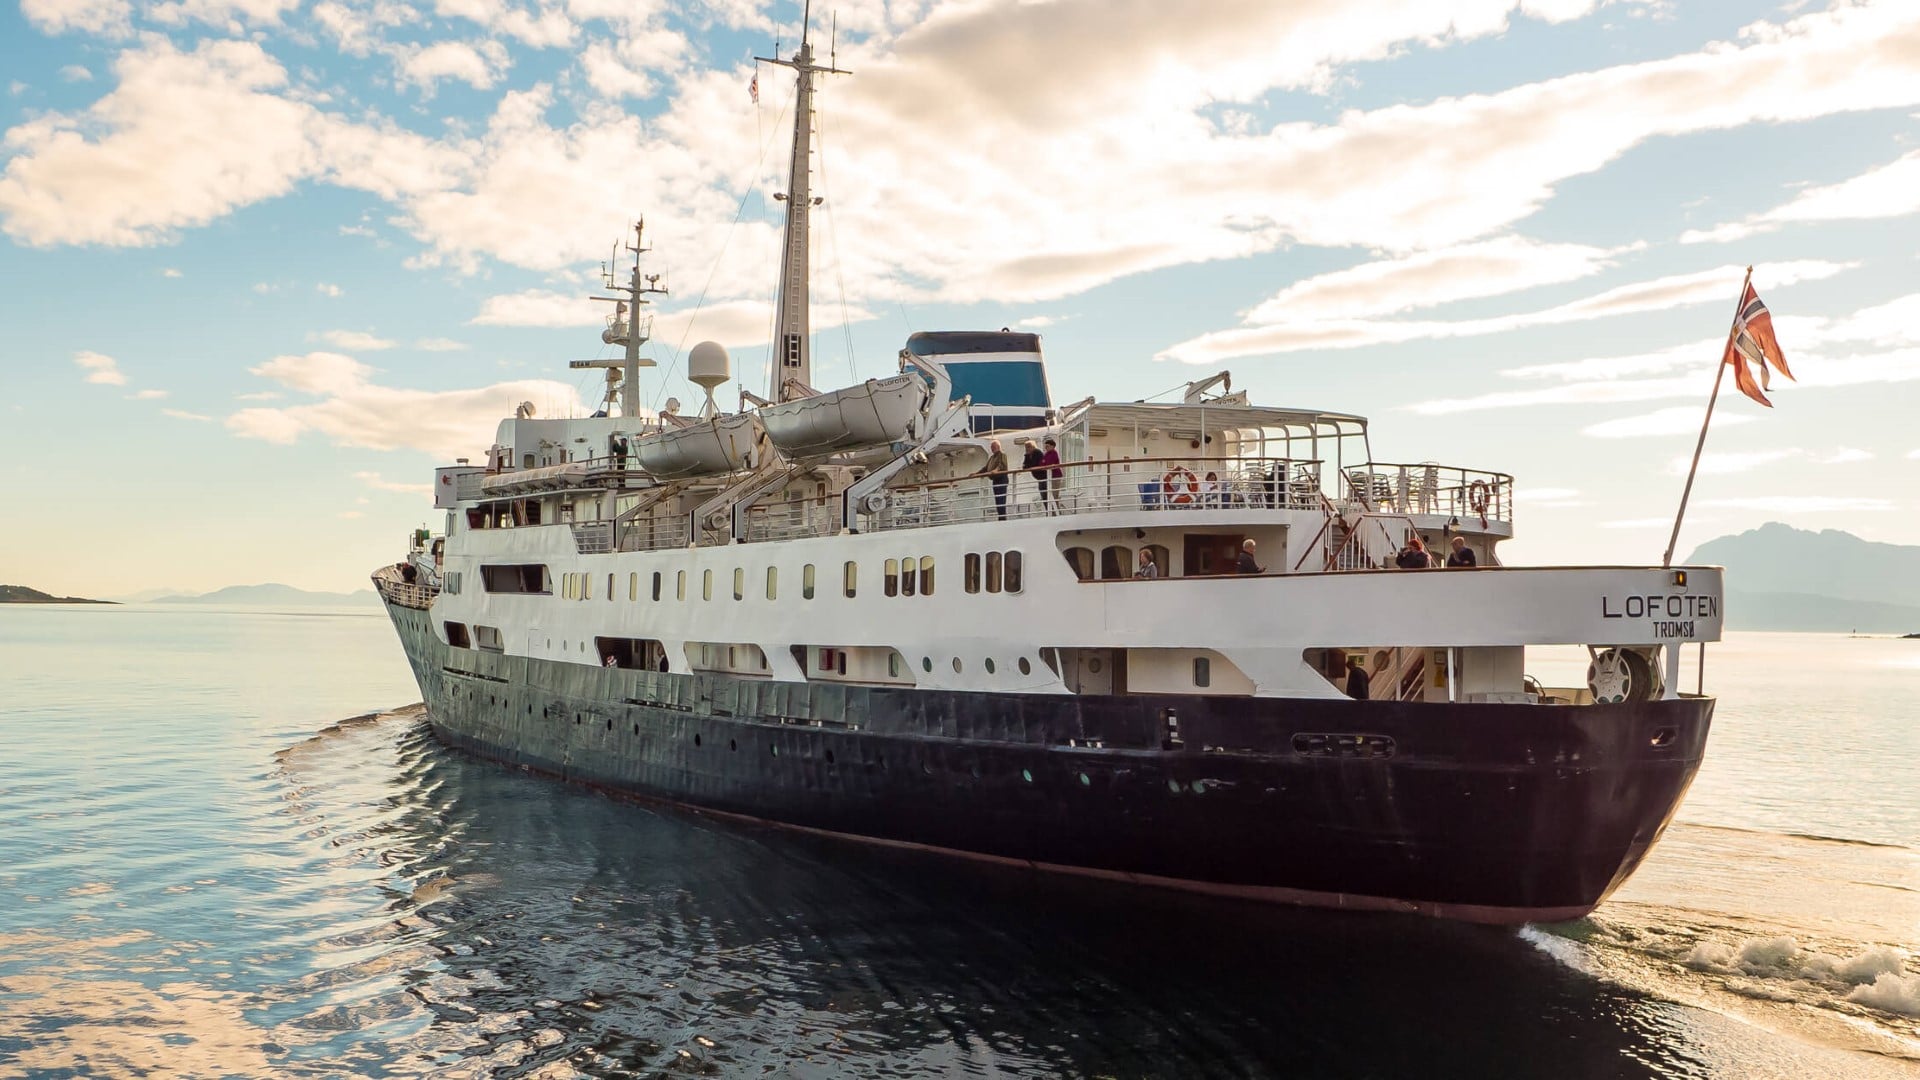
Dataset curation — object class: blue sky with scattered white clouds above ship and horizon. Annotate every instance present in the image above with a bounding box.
[0,0,1920,596]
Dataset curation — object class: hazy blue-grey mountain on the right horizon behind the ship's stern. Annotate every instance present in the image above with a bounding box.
[1686,521,1920,634]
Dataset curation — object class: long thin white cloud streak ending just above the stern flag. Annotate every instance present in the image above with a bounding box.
[1160,259,1855,365]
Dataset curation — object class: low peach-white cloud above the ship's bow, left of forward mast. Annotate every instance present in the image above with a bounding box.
[227,352,586,459]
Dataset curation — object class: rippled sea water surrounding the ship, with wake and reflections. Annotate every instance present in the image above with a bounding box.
[0,605,1920,1078]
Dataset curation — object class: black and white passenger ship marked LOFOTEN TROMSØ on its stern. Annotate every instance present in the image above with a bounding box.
[372,25,1722,924]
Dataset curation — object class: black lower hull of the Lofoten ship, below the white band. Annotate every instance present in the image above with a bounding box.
[388,603,1713,922]
